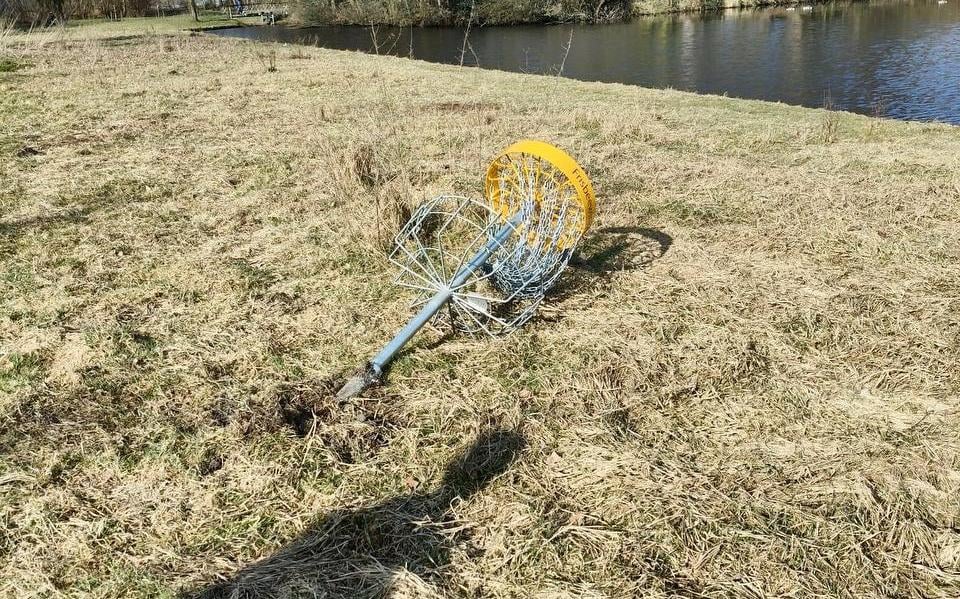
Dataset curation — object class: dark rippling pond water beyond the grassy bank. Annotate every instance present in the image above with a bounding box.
[214,0,960,124]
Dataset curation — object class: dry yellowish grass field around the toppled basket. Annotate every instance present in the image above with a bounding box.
[0,18,960,598]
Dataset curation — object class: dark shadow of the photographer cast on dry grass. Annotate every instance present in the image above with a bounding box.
[183,430,524,599]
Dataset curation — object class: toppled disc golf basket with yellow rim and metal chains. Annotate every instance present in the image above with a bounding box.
[337,140,596,400]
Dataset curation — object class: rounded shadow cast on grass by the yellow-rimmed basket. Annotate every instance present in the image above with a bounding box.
[551,227,673,300]
